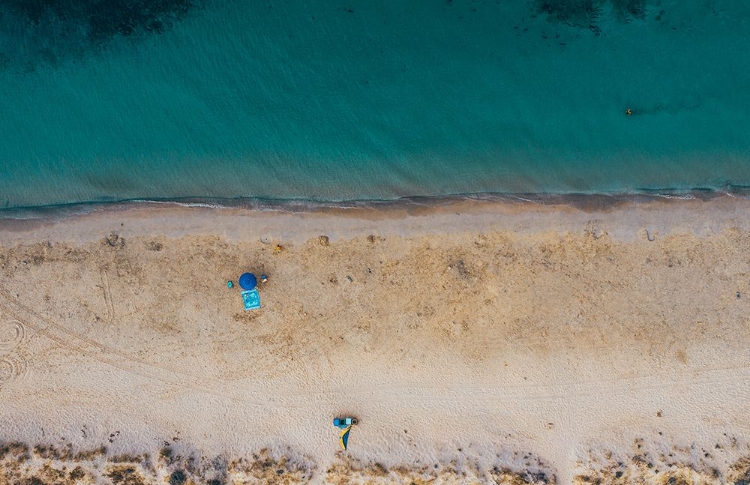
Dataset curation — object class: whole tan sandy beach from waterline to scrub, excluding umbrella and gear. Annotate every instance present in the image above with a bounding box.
[0,196,750,485]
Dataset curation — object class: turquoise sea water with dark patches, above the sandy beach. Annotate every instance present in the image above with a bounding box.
[0,0,750,208]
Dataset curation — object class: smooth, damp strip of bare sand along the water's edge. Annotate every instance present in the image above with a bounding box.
[0,193,750,248]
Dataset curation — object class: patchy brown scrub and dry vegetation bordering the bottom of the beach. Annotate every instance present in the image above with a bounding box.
[8,437,750,485]
